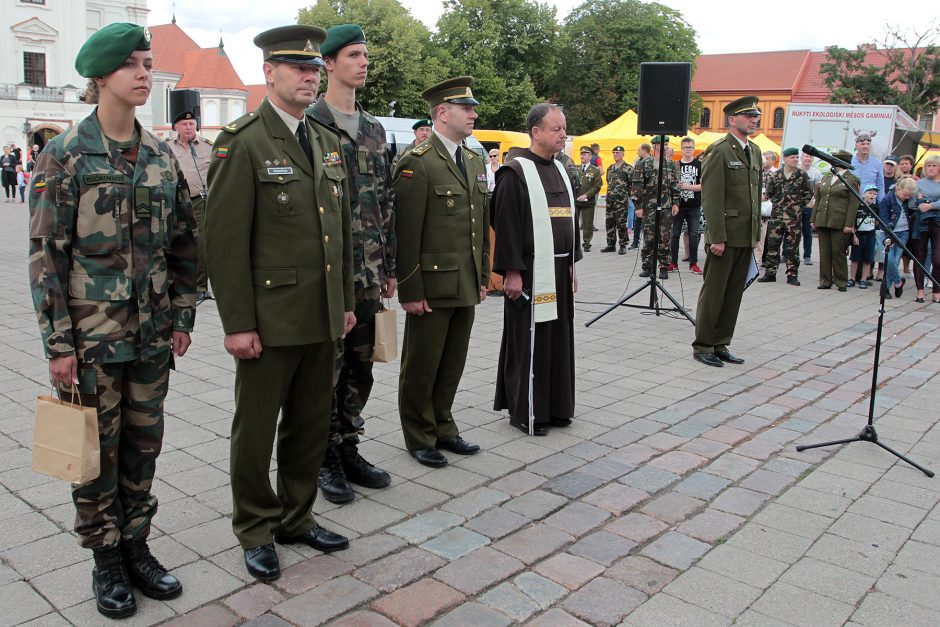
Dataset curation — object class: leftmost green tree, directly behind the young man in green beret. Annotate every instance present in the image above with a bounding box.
[297,0,445,118]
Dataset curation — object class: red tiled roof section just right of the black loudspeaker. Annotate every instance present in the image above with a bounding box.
[692,50,811,93]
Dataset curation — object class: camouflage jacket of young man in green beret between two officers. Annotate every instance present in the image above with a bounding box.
[307,94,397,289]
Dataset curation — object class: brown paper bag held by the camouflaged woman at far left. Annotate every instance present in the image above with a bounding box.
[33,386,101,483]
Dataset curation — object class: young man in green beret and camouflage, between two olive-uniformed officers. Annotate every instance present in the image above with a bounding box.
[307,24,397,503]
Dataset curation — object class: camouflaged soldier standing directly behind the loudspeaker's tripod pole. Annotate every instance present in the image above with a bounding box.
[633,135,679,280]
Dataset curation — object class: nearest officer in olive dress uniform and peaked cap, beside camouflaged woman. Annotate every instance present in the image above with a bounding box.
[206,26,356,581]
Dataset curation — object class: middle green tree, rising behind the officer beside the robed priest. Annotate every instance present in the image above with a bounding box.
[432,0,561,130]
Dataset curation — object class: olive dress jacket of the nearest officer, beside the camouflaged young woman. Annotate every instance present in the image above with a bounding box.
[205,98,355,346]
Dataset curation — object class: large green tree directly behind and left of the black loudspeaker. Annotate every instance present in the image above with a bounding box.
[549,0,699,135]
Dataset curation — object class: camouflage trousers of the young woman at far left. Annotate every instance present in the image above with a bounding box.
[59,350,172,549]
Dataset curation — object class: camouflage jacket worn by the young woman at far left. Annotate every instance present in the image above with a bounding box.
[29,109,196,363]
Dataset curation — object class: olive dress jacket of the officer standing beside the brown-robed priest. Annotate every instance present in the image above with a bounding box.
[392,135,490,309]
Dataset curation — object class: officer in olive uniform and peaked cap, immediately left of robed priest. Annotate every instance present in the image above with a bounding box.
[394,76,490,468]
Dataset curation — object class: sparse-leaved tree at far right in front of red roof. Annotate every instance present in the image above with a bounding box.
[819,22,940,119]
